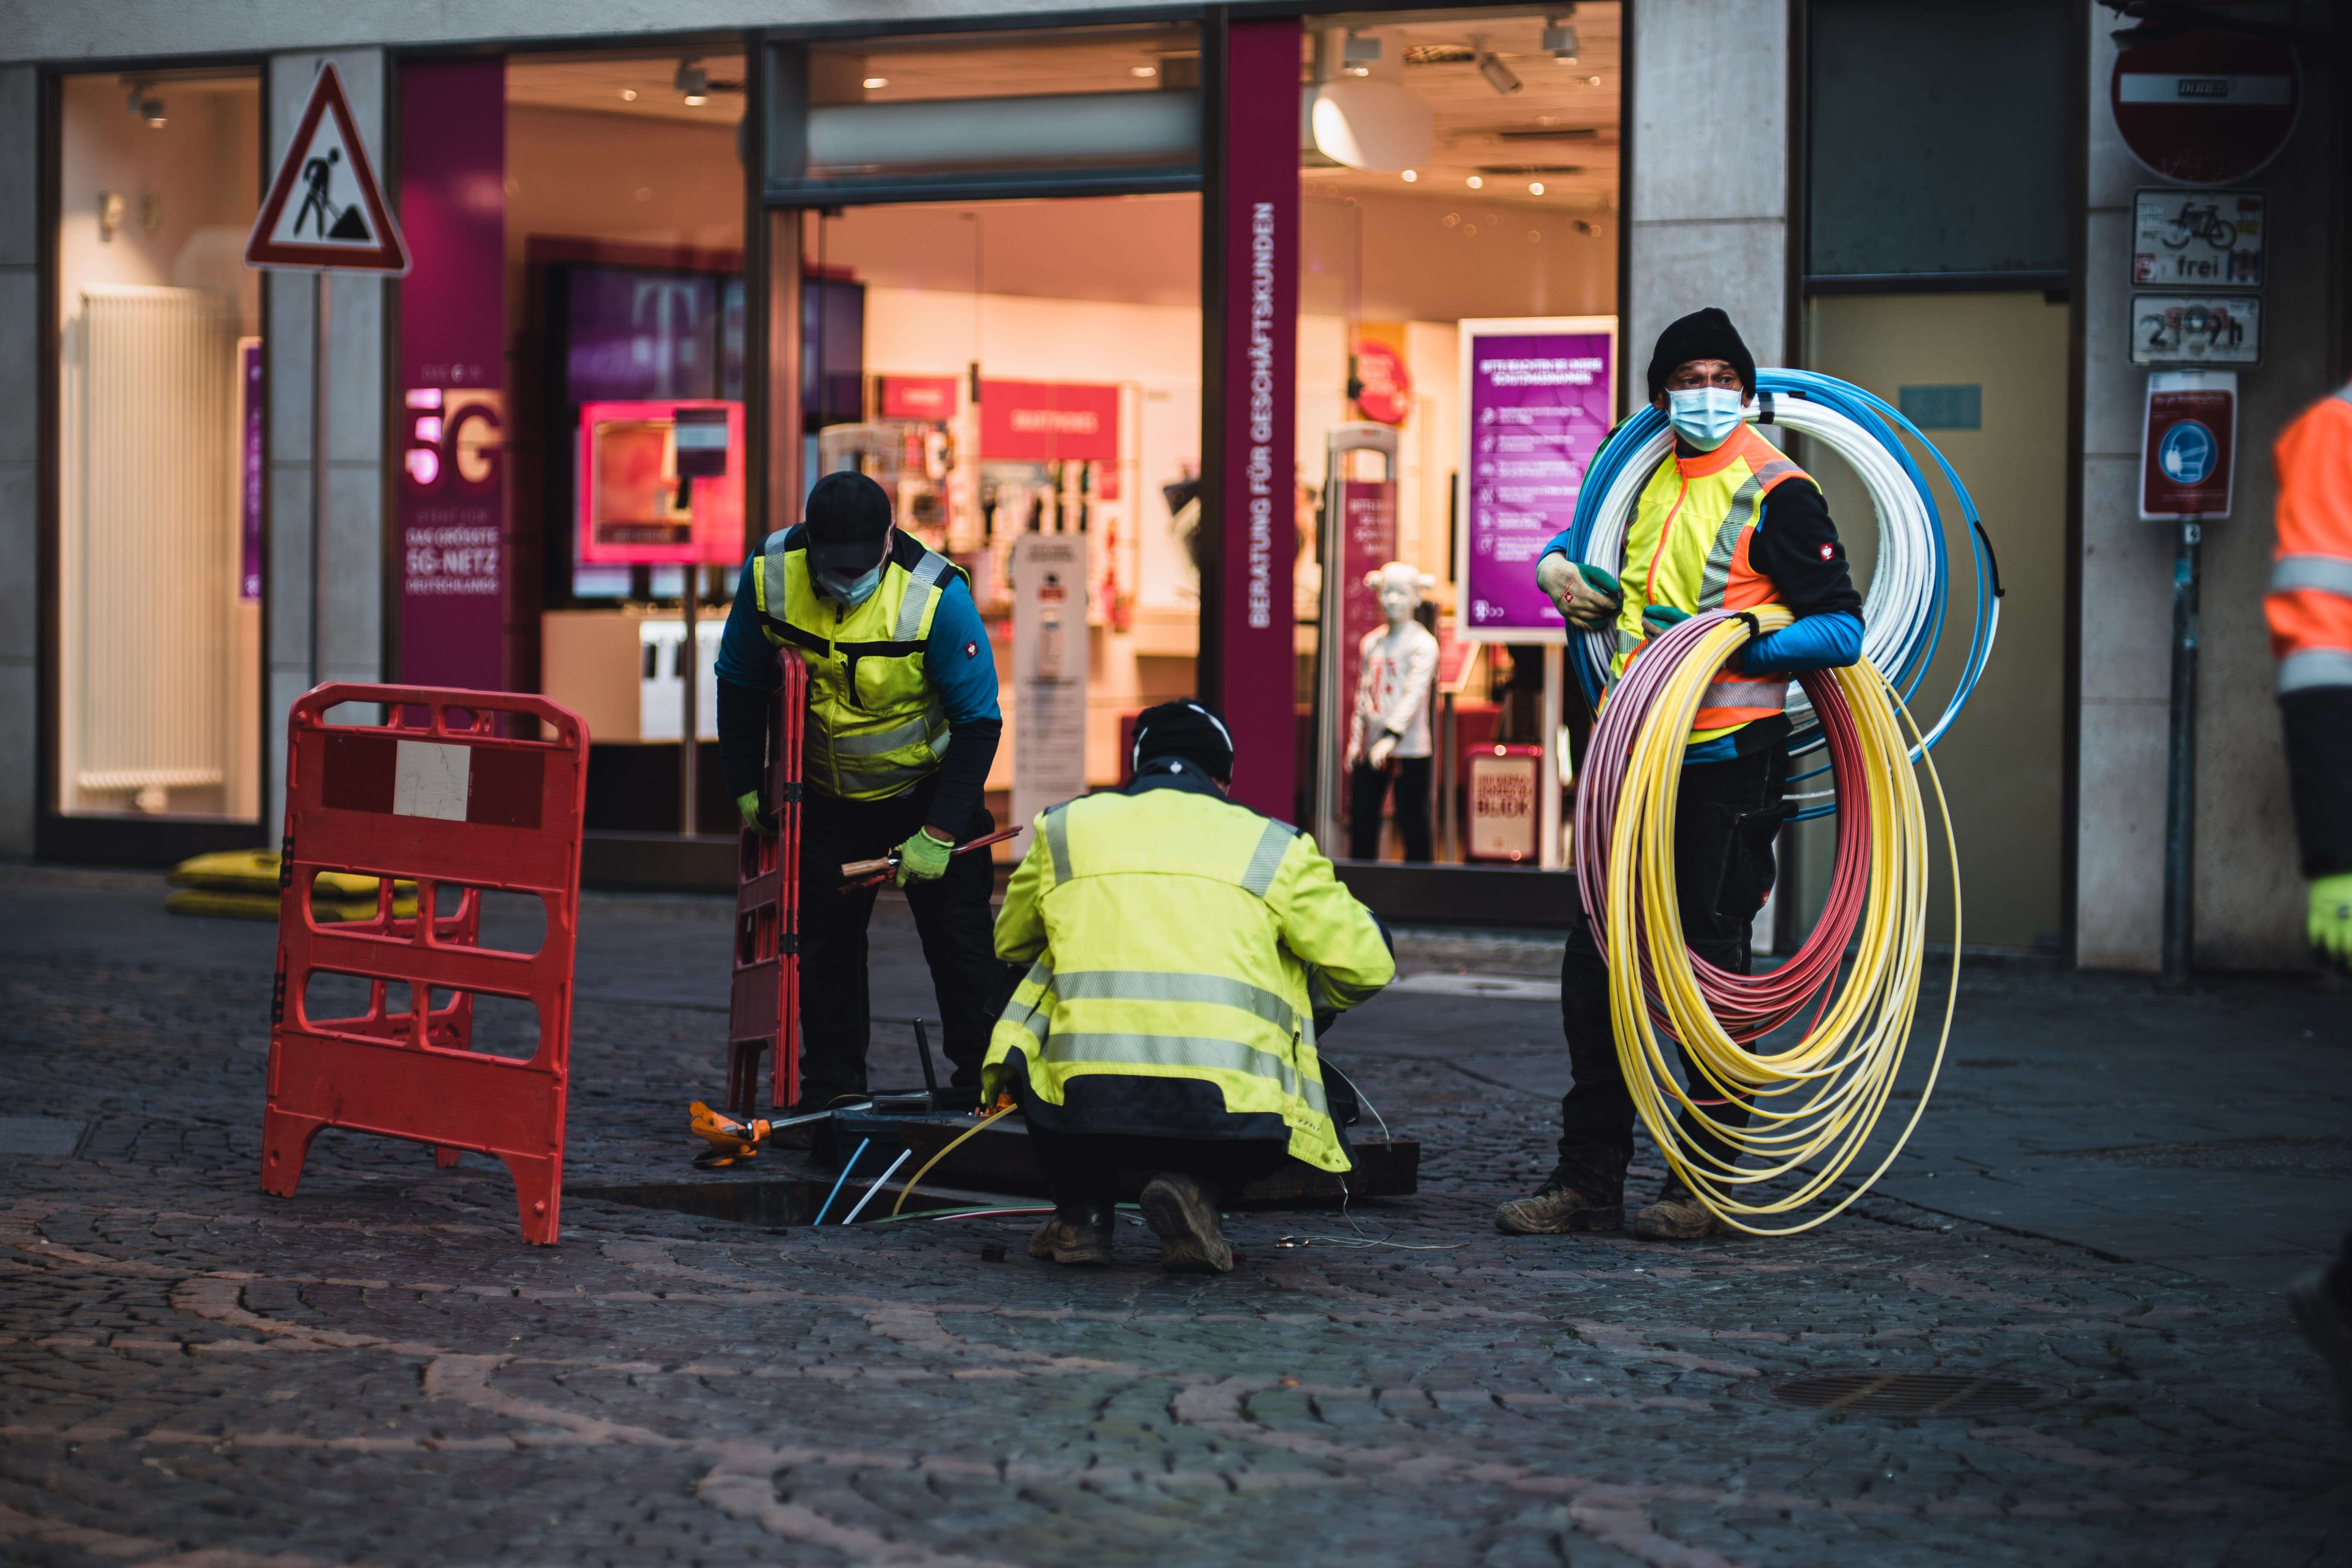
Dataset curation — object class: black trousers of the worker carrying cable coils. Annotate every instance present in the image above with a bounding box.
[1552,745,1788,1204]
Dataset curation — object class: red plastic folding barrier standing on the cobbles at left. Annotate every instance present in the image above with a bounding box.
[261,684,588,1246]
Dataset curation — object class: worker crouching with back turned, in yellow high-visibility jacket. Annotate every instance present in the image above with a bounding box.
[981,703,1397,1274]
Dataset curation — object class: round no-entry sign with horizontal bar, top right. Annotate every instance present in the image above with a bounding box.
[2107,30,2303,186]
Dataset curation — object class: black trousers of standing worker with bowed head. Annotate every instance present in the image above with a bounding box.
[800,780,1011,1109]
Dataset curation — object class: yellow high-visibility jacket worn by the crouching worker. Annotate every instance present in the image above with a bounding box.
[981,788,1397,1171]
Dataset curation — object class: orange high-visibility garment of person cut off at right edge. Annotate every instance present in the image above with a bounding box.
[2262,386,2352,696]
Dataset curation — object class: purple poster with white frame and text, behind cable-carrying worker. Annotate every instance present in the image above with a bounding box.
[1456,315,1616,642]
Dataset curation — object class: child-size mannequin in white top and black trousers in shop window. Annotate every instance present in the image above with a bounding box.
[1348,562,1437,863]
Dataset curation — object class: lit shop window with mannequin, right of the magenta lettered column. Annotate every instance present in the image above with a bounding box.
[1291,5,1623,860]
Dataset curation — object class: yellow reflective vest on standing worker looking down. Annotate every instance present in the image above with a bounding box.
[753,529,957,799]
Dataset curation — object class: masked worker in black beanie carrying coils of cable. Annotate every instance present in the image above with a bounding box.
[1494,308,1863,1239]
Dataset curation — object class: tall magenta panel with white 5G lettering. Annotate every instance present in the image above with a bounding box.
[395,59,508,691]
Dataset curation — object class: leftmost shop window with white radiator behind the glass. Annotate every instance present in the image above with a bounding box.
[57,73,264,821]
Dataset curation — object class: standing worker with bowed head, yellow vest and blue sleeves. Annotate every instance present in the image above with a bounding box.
[717,473,1009,1109]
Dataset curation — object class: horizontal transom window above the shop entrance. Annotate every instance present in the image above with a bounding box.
[769,26,1200,204]
